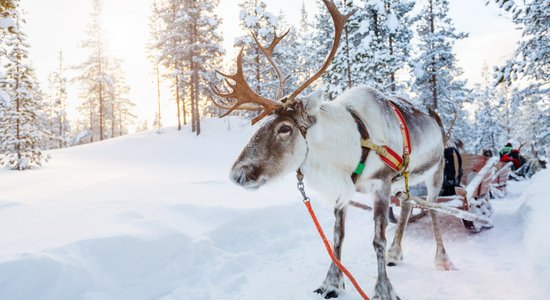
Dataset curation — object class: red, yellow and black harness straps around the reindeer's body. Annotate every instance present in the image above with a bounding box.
[347,102,411,194]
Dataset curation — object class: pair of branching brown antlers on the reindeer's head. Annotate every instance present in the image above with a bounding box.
[211,0,355,124]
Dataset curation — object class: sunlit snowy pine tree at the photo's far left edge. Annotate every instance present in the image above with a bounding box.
[0,7,49,170]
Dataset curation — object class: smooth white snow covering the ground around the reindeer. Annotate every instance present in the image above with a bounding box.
[0,119,550,300]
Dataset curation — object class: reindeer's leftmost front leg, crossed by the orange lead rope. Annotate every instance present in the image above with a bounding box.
[315,206,347,299]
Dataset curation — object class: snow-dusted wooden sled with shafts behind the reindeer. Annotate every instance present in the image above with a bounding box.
[389,154,512,232]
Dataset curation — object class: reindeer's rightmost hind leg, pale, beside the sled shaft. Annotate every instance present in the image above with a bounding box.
[426,160,454,271]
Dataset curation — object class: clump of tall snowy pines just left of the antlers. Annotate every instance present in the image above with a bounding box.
[152,0,224,134]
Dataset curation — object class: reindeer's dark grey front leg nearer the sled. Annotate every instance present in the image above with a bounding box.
[372,181,399,300]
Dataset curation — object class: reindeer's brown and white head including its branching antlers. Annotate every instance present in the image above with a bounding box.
[212,0,353,189]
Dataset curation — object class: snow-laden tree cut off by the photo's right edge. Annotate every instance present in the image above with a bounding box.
[488,0,550,153]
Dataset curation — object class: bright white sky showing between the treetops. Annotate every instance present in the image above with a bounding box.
[21,0,519,126]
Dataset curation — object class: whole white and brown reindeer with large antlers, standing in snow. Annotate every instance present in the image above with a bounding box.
[212,0,452,299]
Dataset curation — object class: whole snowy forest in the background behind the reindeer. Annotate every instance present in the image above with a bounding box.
[0,0,550,170]
